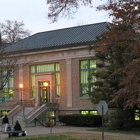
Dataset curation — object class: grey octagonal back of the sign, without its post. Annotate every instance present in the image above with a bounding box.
[97,101,108,115]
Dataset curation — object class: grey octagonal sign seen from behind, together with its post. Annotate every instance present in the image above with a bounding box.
[97,101,108,140]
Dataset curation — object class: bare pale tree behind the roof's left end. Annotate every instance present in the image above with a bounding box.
[0,20,31,43]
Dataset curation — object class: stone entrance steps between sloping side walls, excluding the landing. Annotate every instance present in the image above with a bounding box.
[7,104,47,127]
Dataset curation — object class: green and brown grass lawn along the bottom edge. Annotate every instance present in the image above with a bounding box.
[3,132,139,140]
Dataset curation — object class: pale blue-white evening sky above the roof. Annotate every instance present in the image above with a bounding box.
[0,0,111,35]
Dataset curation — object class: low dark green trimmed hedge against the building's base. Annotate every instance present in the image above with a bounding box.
[59,114,102,127]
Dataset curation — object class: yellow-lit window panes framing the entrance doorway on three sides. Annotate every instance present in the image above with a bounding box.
[30,63,60,98]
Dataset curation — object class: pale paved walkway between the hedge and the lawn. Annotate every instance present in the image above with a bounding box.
[0,126,140,140]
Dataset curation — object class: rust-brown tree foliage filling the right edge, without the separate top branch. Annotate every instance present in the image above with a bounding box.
[89,0,140,109]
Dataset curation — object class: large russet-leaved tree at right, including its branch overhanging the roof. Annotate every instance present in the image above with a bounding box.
[47,0,140,109]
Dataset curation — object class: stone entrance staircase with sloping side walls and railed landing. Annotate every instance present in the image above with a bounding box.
[0,103,58,127]
